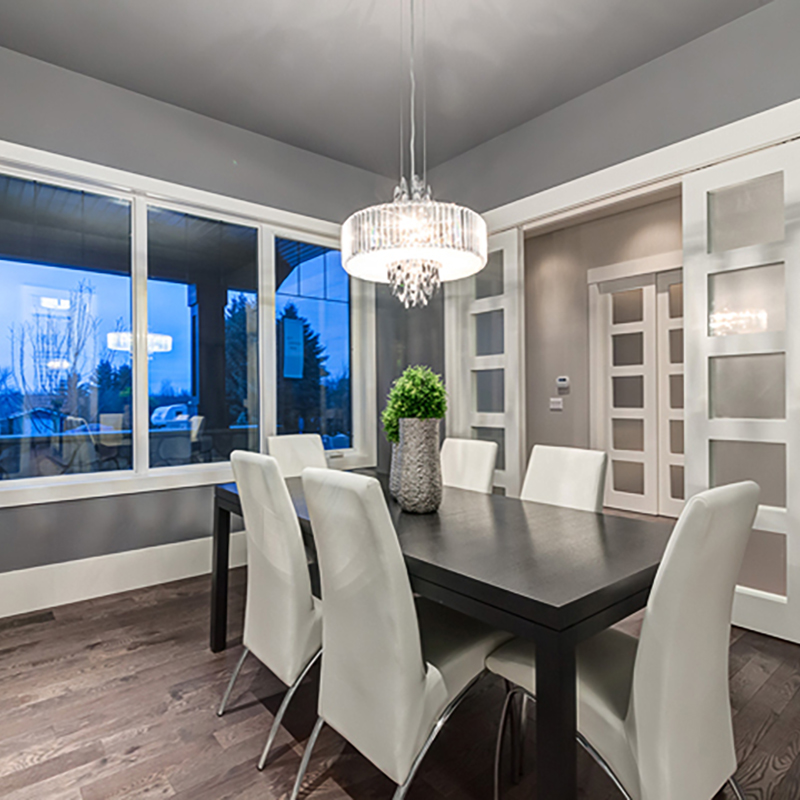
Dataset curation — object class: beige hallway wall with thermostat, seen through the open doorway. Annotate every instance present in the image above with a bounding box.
[525,197,683,452]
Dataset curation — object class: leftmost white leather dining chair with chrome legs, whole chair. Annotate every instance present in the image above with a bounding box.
[217,450,322,769]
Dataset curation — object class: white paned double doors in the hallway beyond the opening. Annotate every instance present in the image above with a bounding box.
[590,263,684,516]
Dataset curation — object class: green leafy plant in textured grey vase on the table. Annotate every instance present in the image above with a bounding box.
[381,366,447,514]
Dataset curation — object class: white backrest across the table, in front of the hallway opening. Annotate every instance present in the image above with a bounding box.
[520,444,608,512]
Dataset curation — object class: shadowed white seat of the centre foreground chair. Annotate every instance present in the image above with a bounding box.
[416,597,511,702]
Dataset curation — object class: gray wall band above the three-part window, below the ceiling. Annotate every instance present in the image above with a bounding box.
[0,48,393,222]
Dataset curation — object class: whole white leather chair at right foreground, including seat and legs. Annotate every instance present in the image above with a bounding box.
[486,481,759,800]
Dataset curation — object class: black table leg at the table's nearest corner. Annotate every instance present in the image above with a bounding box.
[536,633,578,800]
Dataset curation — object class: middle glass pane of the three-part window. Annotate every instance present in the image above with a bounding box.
[147,208,258,467]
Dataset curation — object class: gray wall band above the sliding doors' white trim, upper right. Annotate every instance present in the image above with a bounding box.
[429,0,800,211]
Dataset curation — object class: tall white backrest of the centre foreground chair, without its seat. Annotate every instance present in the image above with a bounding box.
[303,469,434,783]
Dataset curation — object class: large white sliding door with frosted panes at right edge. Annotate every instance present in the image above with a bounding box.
[683,142,800,641]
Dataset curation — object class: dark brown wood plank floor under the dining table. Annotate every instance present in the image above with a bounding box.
[0,570,800,800]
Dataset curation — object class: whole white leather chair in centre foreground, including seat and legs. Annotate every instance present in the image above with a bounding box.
[292,469,510,800]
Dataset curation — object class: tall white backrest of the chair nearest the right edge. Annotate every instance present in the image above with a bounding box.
[626,481,759,800]
